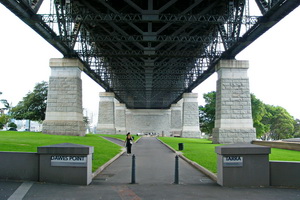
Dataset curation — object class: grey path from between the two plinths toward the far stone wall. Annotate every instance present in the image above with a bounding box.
[95,137,214,184]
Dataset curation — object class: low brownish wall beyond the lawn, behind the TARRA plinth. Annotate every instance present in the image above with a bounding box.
[251,140,300,151]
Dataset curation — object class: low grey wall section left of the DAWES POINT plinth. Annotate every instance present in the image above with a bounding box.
[0,152,39,181]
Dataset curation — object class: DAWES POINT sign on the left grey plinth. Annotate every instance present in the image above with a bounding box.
[50,155,87,167]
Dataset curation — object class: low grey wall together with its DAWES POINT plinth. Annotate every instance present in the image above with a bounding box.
[0,143,94,185]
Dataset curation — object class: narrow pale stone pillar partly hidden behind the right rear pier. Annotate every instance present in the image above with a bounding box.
[171,102,182,136]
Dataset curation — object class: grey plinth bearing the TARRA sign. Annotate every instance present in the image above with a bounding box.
[215,143,271,187]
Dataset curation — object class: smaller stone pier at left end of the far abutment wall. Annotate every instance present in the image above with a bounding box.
[97,92,116,134]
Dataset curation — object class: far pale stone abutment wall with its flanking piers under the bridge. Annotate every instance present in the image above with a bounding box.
[97,92,200,138]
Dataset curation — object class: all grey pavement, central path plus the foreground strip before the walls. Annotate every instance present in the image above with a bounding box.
[0,137,300,200]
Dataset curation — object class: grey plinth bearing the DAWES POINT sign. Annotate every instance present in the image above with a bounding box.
[37,143,94,185]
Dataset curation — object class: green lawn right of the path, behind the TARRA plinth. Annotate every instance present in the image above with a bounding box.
[159,137,300,173]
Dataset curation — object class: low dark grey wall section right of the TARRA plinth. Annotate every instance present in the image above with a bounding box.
[270,161,300,187]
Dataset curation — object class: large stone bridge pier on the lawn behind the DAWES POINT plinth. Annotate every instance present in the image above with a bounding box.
[43,58,85,136]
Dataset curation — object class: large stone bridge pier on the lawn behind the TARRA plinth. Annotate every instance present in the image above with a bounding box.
[213,60,256,143]
